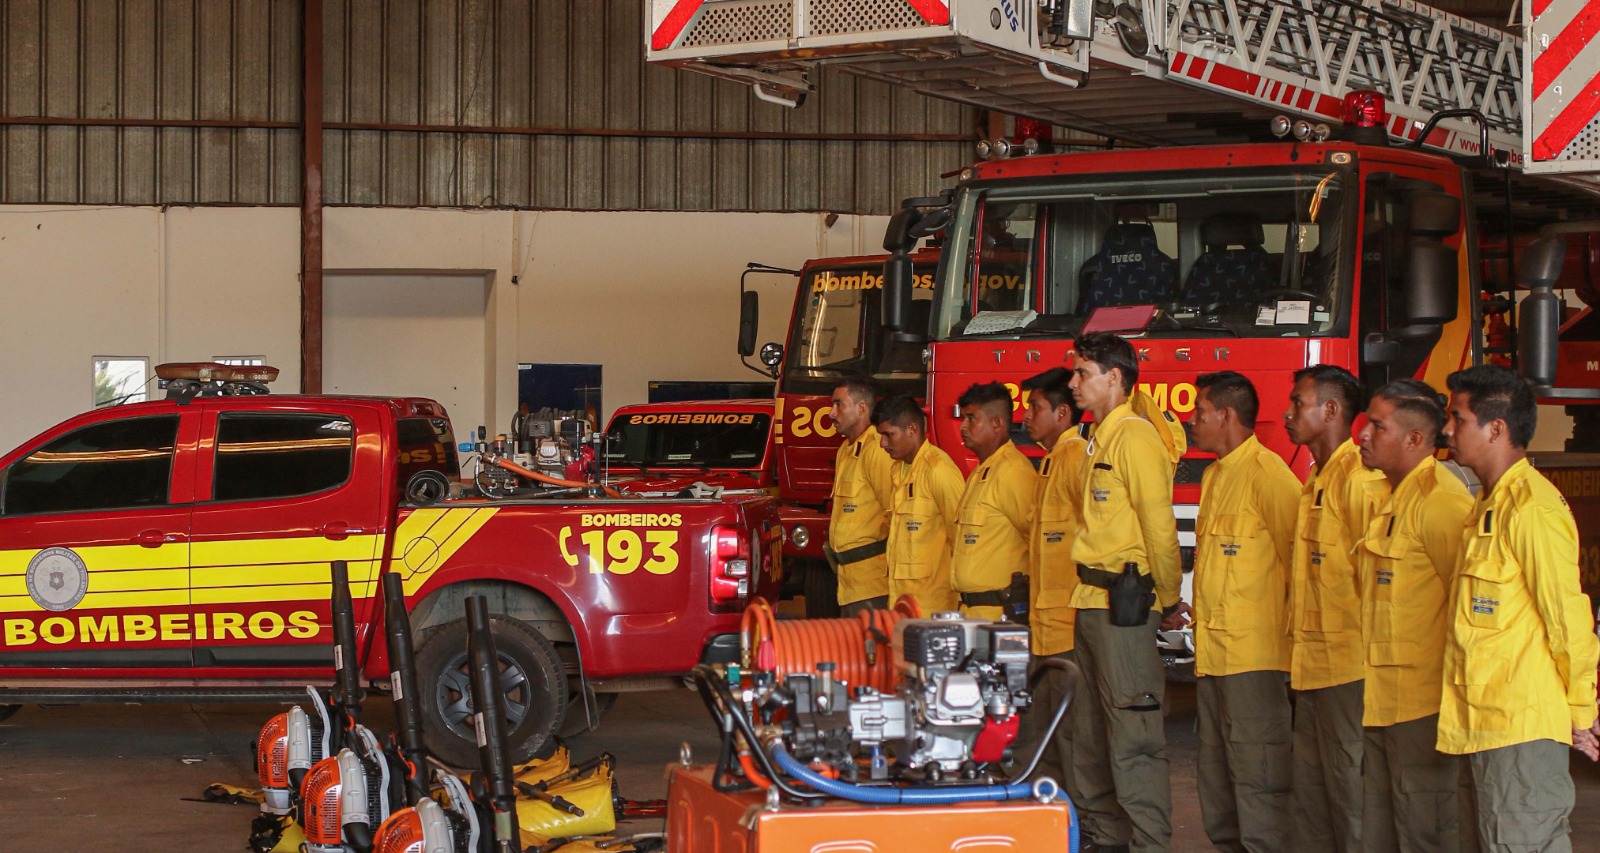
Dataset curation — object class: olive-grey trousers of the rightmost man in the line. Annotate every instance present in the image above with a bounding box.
[1467,741,1576,853]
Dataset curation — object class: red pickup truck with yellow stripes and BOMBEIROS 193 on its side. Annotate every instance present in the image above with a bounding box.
[0,363,782,765]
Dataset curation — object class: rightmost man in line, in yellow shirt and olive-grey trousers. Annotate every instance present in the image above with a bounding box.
[1438,365,1600,853]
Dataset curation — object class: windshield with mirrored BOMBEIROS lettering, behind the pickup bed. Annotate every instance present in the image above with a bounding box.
[606,411,773,471]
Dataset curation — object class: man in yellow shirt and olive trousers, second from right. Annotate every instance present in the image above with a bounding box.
[1357,379,1472,853]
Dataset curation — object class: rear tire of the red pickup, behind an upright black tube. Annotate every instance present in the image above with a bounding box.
[416,615,566,768]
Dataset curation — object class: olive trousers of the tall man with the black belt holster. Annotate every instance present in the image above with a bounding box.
[1072,610,1173,851]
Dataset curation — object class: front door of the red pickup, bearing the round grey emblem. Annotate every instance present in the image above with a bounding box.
[0,406,200,675]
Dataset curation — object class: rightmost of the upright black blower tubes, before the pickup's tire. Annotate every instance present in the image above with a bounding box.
[467,595,522,853]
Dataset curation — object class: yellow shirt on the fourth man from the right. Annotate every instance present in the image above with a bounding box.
[1194,435,1299,675]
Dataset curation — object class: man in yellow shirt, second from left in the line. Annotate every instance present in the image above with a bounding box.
[872,395,965,616]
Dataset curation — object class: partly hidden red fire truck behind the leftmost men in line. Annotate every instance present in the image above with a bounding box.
[739,251,939,618]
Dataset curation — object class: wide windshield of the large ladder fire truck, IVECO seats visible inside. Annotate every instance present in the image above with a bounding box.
[931,168,1355,341]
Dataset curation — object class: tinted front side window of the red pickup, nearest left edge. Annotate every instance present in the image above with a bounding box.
[5,414,178,515]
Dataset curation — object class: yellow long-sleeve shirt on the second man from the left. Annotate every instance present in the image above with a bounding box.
[888,442,966,616]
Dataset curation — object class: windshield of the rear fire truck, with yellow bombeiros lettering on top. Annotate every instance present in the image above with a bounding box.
[782,264,934,394]
